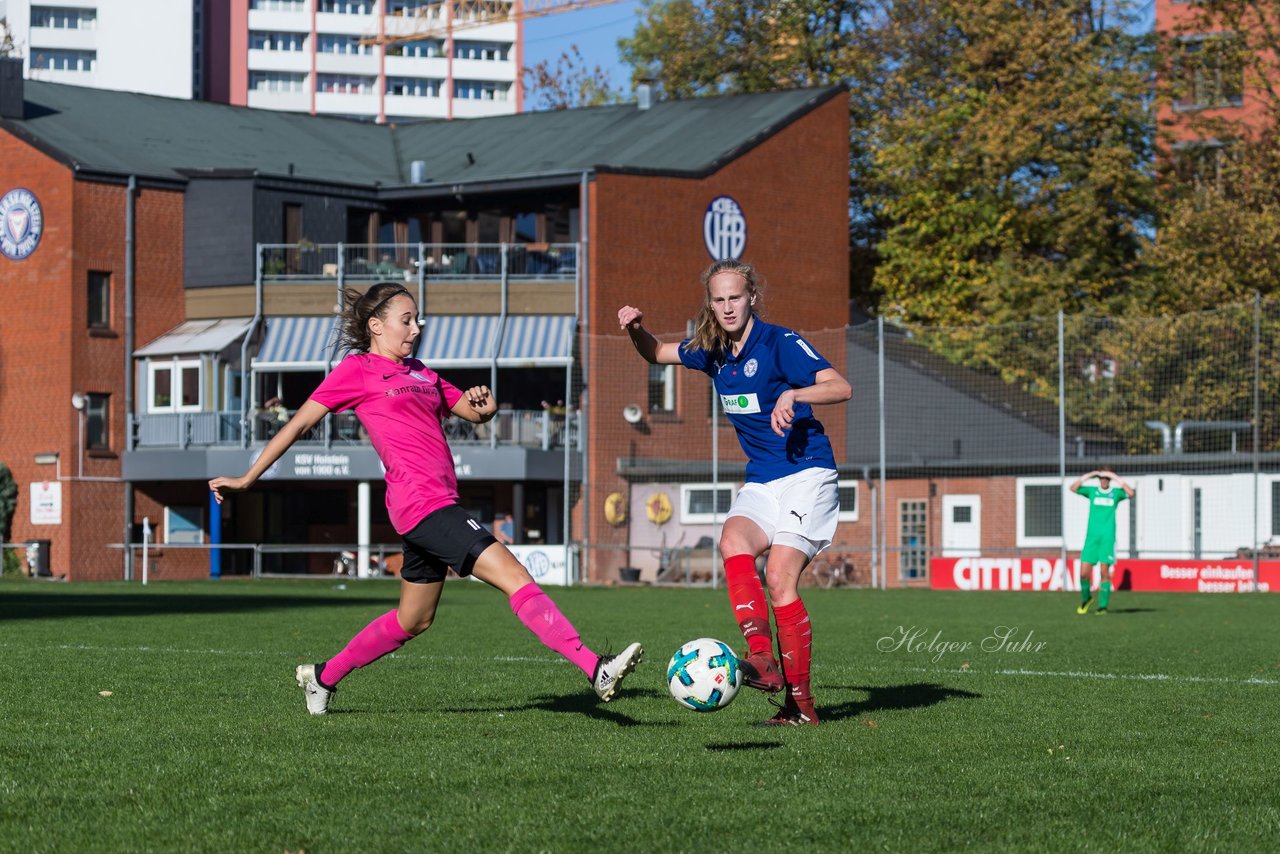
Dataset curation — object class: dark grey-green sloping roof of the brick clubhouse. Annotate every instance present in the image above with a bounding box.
[0,81,845,187]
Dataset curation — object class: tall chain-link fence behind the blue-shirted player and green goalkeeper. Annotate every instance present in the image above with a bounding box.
[572,301,1280,589]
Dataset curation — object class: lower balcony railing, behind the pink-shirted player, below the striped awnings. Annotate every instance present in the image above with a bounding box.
[132,410,581,451]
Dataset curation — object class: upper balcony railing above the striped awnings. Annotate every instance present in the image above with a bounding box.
[260,243,579,283]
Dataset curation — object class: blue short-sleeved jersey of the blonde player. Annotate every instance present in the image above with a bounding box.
[680,318,836,483]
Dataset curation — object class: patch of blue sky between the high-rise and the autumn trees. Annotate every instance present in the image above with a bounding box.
[524,0,640,97]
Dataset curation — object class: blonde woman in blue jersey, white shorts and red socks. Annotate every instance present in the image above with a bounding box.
[618,261,852,726]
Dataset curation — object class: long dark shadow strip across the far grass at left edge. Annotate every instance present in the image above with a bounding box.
[0,592,394,622]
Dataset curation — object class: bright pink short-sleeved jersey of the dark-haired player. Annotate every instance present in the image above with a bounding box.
[311,353,462,534]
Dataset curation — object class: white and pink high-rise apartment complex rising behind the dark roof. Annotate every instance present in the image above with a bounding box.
[0,0,521,122]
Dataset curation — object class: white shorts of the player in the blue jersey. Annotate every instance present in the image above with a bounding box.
[726,469,840,560]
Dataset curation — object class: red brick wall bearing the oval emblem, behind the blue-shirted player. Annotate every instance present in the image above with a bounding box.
[586,96,849,580]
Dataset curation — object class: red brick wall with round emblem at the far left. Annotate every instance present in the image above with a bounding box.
[0,133,183,580]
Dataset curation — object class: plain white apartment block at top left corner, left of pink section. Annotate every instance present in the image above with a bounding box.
[0,0,201,99]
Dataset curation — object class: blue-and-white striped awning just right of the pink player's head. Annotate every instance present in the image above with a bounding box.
[417,315,575,369]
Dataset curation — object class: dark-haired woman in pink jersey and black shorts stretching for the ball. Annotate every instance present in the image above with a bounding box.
[216,282,644,714]
